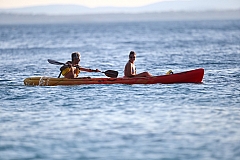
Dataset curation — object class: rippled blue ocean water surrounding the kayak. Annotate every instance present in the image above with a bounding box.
[0,20,240,160]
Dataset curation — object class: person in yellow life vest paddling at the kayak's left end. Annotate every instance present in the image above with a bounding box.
[60,52,101,78]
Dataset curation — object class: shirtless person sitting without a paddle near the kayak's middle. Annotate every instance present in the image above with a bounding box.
[124,51,152,77]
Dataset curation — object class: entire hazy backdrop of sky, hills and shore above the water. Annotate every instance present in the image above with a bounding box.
[0,0,240,24]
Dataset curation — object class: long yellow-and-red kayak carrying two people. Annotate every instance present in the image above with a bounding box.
[24,68,204,86]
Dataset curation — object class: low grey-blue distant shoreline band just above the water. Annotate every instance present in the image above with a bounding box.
[0,9,240,25]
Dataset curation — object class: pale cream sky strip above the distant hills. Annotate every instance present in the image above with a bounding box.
[0,0,171,8]
